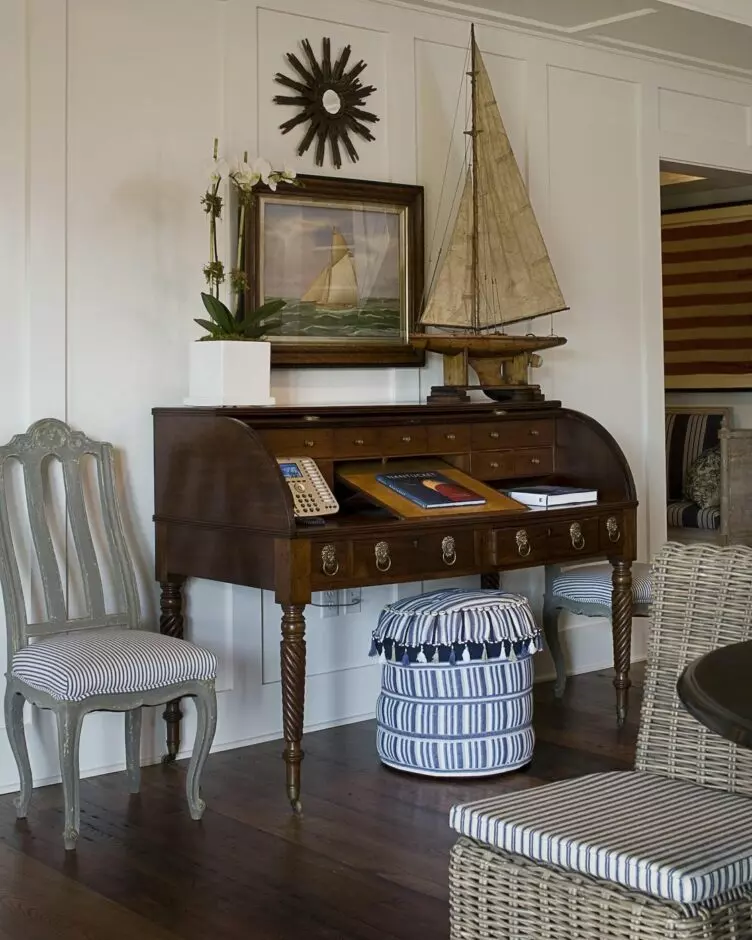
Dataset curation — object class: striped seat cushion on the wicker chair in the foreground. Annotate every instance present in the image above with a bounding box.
[451,771,752,906]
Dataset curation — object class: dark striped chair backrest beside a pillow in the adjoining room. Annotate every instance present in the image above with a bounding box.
[666,408,731,499]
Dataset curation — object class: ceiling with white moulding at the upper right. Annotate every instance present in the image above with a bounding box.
[390,0,752,78]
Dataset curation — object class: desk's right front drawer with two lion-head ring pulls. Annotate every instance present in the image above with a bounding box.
[492,516,602,565]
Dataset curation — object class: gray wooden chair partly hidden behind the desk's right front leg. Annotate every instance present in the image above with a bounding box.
[542,562,651,698]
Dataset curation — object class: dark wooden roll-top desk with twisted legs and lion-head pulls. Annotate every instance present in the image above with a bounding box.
[153,402,637,808]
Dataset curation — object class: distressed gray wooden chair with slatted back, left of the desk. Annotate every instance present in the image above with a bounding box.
[0,419,217,849]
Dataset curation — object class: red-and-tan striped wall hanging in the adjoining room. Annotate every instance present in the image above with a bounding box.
[662,204,752,389]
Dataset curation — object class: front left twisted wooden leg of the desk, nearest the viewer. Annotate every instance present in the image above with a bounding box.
[281,604,305,813]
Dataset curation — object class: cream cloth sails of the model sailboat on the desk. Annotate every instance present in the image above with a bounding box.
[421,39,566,331]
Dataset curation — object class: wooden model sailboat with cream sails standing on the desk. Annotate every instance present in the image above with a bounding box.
[410,29,567,401]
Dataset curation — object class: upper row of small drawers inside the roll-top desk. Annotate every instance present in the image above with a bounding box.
[259,419,554,460]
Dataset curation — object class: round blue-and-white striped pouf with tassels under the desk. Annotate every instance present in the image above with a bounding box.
[371,588,542,777]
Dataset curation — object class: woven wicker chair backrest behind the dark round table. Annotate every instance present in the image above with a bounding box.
[635,542,752,795]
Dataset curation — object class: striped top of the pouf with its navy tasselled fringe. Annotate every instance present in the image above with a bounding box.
[371,588,541,665]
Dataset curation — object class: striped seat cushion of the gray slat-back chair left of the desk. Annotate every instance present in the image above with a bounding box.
[11,629,217,702]
